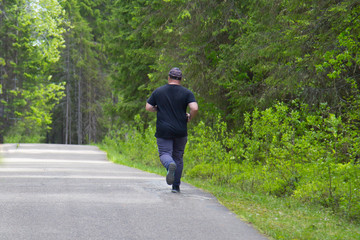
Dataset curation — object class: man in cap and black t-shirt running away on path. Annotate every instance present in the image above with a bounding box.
[145,68,198,193]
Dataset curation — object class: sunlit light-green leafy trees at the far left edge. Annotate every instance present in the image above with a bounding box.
[0,0,63,142]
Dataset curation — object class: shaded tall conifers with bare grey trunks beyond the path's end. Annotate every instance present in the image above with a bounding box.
[50,0,108,144]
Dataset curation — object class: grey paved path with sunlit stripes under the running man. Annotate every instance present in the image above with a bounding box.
[0,144,266,240]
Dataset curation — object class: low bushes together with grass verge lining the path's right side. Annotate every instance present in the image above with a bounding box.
[103,100,360,239]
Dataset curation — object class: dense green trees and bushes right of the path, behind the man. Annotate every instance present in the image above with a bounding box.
[100,0,360,219]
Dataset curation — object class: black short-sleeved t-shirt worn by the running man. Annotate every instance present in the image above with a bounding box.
[147,84,196,138]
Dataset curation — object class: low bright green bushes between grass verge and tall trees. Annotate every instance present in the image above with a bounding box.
[104,102,360,220]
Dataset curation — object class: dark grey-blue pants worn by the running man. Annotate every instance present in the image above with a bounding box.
[157,137,187,186]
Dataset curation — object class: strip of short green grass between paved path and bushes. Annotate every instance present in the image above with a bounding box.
[100,146,360,240]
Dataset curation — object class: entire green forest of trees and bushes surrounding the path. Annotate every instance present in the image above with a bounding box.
[0,0,360,233]
